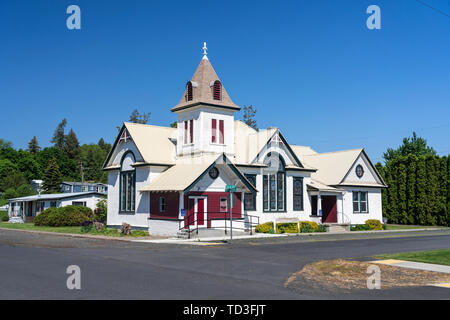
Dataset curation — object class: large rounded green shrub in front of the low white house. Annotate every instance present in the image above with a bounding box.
[33,206,93,227]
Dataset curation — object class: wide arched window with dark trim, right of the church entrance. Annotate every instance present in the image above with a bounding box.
[263,152,286,211]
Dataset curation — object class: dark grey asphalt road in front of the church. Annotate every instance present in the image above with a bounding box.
[0,230,450,299]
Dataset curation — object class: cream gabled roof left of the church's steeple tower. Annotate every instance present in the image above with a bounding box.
[103,122,177,169]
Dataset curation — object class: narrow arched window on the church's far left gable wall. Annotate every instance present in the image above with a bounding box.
[119,151,136,214]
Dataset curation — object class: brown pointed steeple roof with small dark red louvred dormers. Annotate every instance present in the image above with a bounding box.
[171,47,241,112]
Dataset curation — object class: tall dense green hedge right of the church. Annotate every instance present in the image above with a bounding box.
[378,155,450,226]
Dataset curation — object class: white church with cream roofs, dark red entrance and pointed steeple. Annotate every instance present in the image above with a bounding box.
[104,45,386,235]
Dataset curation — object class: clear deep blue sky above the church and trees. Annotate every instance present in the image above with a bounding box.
[0,0,450,162]
